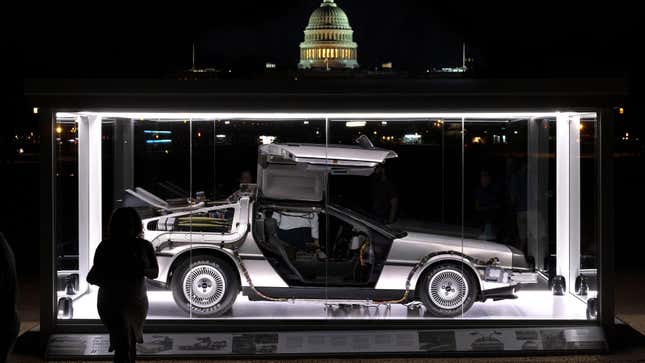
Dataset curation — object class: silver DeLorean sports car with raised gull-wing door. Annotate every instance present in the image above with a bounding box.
[144,144,536,317]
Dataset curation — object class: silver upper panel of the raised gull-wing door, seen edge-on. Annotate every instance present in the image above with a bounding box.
[260,143,398,167]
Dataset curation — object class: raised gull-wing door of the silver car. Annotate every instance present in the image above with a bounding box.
[257,144,397,202]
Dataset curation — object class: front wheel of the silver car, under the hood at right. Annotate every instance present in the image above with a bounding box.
[419,263,478,317]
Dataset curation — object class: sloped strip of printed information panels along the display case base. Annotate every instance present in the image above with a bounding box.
[46,326,608,360]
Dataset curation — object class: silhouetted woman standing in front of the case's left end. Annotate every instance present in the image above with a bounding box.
[87,208,159,363]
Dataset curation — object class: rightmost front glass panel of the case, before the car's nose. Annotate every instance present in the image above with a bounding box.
[464,115,597,319]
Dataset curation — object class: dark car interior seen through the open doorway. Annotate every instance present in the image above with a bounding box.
[253,207,391,287]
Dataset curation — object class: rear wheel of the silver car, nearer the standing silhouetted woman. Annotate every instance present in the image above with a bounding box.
[170,256,240,316]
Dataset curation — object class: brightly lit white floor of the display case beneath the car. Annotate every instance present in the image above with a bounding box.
[65,290,595,319]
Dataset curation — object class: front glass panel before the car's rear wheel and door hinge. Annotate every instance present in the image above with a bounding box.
[184,118,325,319]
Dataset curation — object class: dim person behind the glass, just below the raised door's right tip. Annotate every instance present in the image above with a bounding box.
[372,166,399,224]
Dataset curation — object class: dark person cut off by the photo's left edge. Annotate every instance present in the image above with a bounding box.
[0,233,20,362]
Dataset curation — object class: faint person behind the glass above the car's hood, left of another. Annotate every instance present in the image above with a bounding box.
[475,170,502,241]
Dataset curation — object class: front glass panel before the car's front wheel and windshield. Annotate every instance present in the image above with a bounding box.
[327,118,467,319]
